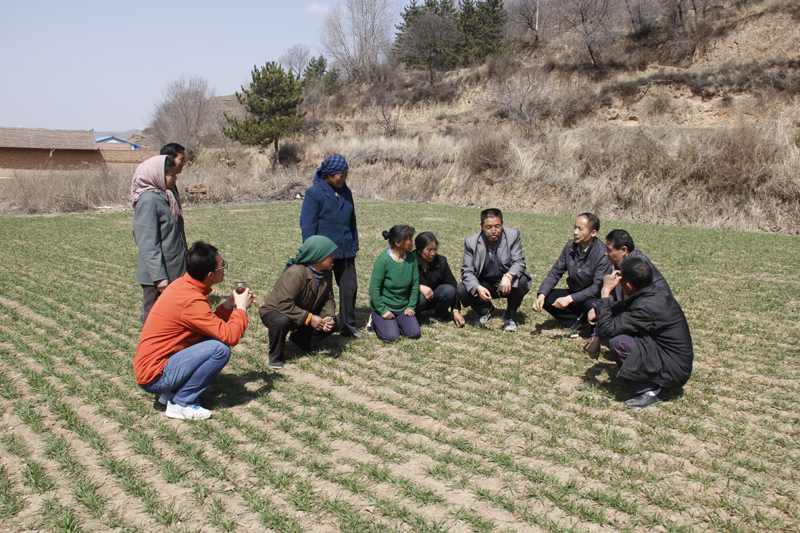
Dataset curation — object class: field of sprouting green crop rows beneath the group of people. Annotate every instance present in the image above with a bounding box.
[0,202,800,532]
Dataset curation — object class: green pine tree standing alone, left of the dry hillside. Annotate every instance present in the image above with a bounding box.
[223,61,305,162]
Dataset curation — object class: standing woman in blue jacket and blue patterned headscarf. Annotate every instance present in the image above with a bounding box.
[300,154,363,339]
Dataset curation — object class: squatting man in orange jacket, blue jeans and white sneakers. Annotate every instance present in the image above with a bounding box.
[133,241,255,420]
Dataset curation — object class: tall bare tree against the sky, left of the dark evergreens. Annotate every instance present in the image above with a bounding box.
[320,0,395,81]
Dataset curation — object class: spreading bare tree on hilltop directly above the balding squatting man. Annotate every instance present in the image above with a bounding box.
[553,0,617,67]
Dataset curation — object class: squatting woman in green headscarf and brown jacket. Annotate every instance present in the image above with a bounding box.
[258,235,338,368]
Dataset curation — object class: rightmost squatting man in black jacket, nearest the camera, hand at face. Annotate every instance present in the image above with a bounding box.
[594,257,694,408]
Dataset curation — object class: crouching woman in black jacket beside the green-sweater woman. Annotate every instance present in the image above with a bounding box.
[414,231,464,328]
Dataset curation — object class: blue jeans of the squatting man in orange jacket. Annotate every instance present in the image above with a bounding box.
[142,337,231,407]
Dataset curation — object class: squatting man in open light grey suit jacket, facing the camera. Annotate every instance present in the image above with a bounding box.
[457,209,531,331]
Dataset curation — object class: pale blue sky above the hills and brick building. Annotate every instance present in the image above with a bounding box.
[0,0,336,132]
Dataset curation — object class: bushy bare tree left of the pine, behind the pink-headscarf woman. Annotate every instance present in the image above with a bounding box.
[149,76,215,156]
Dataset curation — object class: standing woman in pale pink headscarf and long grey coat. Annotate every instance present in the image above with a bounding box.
[131,155,187,324]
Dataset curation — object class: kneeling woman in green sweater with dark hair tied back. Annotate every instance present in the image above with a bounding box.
[369,225,420,342]
